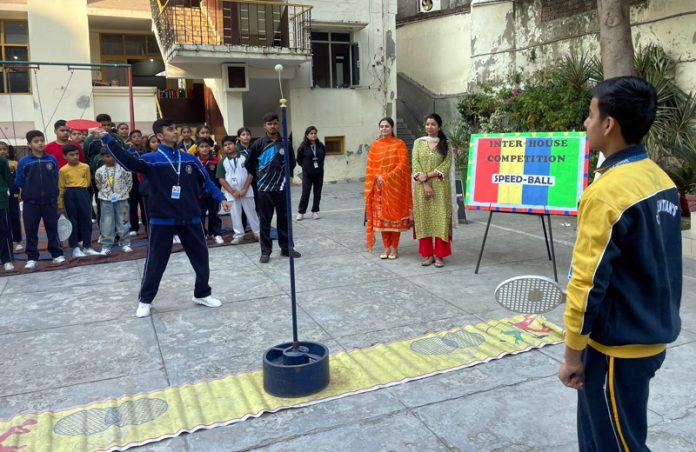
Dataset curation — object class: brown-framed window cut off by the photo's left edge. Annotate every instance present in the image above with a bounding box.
[0,20,31,94]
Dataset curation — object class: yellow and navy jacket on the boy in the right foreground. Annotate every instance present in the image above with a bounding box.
[565,145,682,358]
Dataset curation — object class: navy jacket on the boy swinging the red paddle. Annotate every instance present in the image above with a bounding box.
[102,135,225,225]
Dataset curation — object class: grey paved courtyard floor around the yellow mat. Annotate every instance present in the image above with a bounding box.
[0,183,696,451]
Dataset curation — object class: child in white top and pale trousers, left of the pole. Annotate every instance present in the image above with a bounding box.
[216,136,259,245]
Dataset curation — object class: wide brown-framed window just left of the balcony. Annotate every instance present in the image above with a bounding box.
[99,33,167,89]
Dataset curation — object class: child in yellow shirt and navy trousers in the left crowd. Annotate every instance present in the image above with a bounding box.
[58,144,99,257]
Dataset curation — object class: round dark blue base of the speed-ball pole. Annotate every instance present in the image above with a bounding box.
[263,341,330,397]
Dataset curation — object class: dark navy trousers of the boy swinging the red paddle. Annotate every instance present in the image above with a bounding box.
[139,222,212,303]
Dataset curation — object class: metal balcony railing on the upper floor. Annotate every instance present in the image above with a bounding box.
[155,0,312,56]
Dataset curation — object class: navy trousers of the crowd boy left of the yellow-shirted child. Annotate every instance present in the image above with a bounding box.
[22,202,63,261]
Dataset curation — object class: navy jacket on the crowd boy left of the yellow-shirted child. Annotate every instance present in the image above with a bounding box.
[15,154,58,205]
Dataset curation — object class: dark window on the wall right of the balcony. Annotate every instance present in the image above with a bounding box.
[312,32,360,88]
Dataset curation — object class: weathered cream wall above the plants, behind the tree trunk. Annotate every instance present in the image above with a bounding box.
[396,0,696,138]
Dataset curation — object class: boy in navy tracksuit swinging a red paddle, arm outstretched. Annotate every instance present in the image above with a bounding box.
[93,119,230,317]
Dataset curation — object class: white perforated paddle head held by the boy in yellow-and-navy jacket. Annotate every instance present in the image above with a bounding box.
[495,275,566,314]
